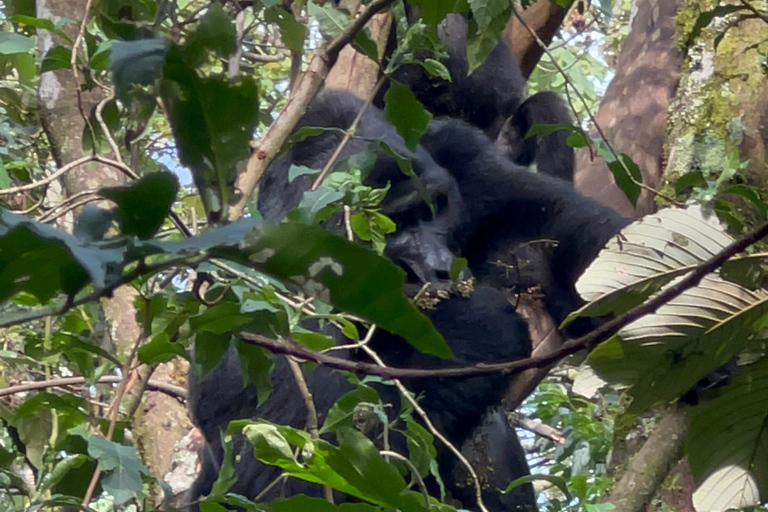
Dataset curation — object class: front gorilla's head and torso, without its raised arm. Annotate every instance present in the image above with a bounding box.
[190,92,536,512]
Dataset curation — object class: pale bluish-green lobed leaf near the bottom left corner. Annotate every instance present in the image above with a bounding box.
[88,435,149,505]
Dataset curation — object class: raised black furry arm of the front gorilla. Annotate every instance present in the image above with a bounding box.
[422,119,629,322]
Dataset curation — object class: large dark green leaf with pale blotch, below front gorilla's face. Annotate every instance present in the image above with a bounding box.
[250,222,450,357]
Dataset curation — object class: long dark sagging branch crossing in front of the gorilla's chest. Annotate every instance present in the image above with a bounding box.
[242,216,768,379]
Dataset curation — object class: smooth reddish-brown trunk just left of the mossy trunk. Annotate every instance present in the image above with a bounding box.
[575,0,681,218]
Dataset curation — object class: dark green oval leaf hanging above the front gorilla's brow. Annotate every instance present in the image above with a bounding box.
[384,80,432,149]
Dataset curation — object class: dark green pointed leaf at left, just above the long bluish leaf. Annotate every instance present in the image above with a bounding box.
[99,172,179,240]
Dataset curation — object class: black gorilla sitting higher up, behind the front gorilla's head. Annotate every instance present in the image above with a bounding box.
[374,11,574,181]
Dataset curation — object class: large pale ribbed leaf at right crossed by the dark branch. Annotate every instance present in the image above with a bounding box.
[577,207,768,412]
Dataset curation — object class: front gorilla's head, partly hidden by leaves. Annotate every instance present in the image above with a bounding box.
[258,91,466,287]
